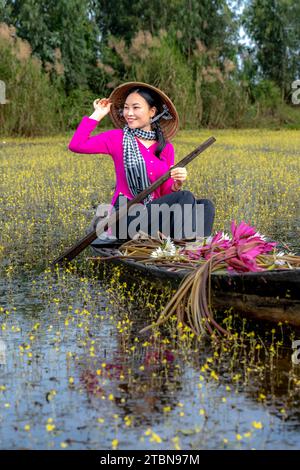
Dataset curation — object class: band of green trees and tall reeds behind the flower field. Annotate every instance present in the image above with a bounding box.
[0,0,300,136]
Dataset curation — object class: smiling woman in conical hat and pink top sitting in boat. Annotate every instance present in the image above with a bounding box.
[69,82,214,239]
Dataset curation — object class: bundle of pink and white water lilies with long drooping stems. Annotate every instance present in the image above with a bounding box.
[94,221,300,335]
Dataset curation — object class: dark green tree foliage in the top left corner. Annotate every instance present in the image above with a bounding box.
[0,0,98,93]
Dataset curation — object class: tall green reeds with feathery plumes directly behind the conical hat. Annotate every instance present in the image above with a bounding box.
[103,30,248,128]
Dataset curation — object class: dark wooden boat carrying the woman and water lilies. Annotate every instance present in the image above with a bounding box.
[92,241,300,326]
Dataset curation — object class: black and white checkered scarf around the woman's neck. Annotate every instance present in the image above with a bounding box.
[123,125,156,205]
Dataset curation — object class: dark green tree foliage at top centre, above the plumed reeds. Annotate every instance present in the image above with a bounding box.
[93,0,237,57]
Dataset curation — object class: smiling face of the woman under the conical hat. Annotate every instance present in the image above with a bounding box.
[123,93,156,131]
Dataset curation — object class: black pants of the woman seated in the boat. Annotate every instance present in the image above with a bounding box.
[114,191,215,240]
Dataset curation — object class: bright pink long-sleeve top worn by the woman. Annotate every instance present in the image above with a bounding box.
[68,116,174,205]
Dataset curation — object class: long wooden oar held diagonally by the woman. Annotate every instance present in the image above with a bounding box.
[51,137,216,267]
